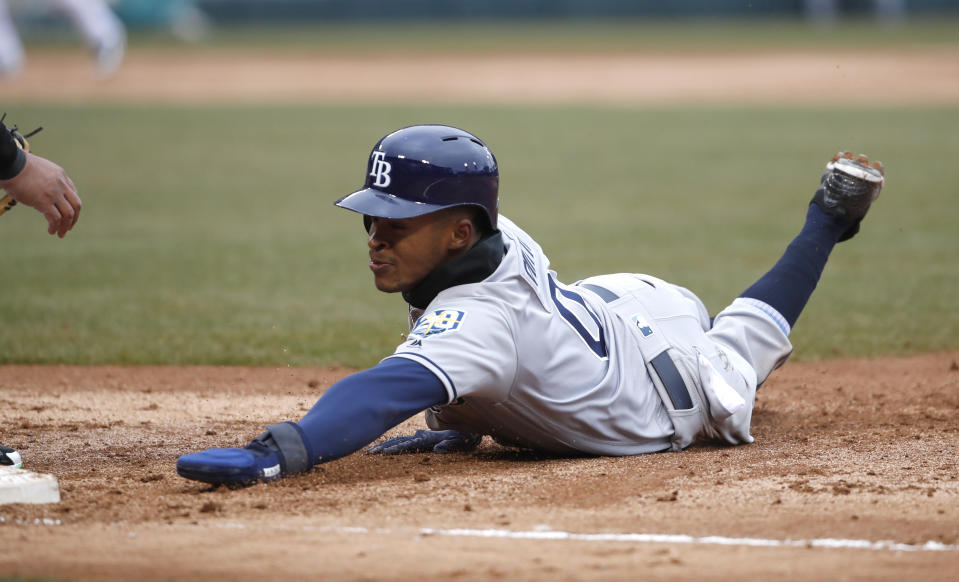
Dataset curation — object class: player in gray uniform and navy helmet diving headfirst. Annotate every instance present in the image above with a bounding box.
[177,125,883,483]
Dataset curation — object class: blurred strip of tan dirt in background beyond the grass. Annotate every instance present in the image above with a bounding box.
[0,46,959,105]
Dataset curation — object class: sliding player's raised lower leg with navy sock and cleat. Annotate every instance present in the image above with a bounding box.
[710,153,883,383]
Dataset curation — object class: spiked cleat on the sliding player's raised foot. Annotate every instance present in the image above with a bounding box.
[812,152,885,242]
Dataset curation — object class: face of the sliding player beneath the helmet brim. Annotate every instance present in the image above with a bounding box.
[368,212,462,293]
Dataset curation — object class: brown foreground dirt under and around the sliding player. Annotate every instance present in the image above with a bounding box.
[0,353,959,581]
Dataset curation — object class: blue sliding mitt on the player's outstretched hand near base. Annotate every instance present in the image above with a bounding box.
[176,433,282,484]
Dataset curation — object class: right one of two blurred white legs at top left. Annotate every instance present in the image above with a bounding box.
[57,0,126,77]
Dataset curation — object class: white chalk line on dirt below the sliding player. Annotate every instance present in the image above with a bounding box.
[206,522,959,552]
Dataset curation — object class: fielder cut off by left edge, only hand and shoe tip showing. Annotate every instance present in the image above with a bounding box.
[0,116,82,467]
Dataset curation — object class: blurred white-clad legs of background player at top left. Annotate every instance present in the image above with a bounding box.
[0,0,126,77]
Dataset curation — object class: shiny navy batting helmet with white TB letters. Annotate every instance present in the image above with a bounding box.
[336,125,499,229]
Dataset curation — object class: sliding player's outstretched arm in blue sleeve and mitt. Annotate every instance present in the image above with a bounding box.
[177,358,448,483]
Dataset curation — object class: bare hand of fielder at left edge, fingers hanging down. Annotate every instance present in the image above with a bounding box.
[0,153,83,238]
